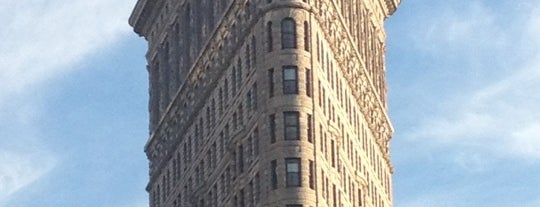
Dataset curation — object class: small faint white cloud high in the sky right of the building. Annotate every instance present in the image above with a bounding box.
[410,0,507,57]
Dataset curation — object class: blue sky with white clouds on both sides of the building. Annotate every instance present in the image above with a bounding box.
[0,0,540,207]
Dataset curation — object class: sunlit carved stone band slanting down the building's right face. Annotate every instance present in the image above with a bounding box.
[315,1,393,166]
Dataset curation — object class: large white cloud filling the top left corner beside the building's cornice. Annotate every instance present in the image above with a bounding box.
[0,0,134,103]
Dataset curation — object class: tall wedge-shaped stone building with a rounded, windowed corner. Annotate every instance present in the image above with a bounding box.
[130,0,399,207]
